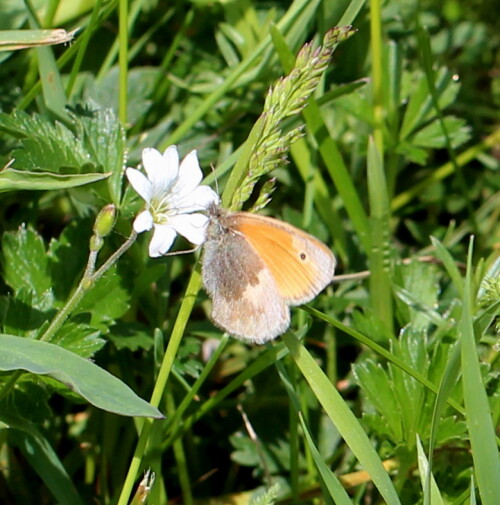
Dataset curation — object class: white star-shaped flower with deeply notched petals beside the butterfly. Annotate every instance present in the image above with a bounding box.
[126,146,218,258]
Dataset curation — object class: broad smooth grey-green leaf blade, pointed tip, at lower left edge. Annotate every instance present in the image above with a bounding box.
[0,334,163,419]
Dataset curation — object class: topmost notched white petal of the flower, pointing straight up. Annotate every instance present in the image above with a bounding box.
[142,146,179,195]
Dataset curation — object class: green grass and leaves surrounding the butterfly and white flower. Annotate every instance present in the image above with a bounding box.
[0,0,500,505]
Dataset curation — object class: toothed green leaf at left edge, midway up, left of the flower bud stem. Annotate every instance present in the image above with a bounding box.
[2,226,52,309]
